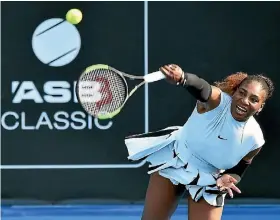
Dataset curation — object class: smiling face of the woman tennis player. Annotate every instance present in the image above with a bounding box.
[231,81,266,121]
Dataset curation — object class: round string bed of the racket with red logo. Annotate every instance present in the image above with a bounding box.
[78,69,127,115]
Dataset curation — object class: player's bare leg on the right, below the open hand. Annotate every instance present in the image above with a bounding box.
[188,196,223,220]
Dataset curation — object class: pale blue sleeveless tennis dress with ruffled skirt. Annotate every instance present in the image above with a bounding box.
[125,92,265,206]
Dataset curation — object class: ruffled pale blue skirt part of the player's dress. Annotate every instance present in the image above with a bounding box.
[125,126,226,206]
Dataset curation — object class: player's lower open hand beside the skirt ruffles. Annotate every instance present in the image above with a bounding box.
[217,174,241,198]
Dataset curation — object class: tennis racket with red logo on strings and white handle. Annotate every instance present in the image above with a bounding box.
[76,64,165,119]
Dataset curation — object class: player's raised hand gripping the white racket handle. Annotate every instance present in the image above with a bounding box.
[159,64,184,84]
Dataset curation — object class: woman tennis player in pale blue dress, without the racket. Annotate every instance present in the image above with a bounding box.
[125,64,274,220]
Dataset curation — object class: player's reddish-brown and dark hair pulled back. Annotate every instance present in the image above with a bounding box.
[214,72,274,99]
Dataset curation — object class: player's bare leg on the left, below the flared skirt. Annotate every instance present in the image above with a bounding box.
[142,173,185,220]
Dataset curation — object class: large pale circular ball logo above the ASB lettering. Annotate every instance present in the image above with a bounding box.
[32,18,81,67]
